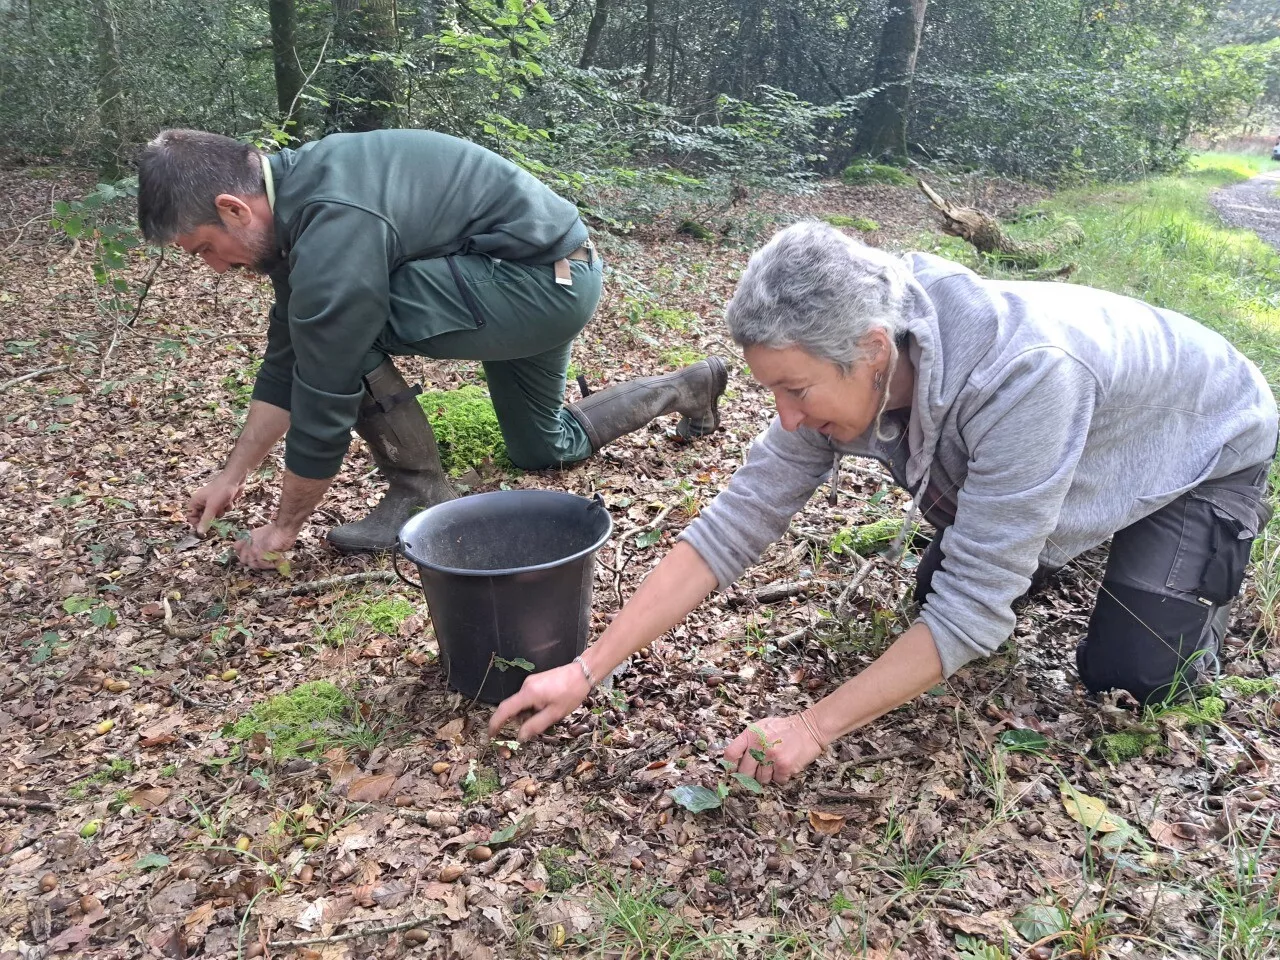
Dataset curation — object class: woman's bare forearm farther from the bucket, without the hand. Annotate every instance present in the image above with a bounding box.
[813,621,942,742]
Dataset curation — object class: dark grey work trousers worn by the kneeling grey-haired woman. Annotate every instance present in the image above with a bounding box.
[915,463,1271,703]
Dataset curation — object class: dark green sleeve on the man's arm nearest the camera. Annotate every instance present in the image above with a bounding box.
[284,201,399,480]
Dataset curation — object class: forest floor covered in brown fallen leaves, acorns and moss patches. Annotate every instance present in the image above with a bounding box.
[0,160,1280,960]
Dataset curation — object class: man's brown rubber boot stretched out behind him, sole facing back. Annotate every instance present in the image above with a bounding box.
[568,357,728,453]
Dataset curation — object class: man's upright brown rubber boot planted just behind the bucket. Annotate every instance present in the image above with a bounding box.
[329,360,458,553]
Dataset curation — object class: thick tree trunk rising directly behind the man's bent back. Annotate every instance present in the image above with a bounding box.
[329,0,402,132]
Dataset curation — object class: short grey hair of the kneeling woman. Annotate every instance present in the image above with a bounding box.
[724,220,909,374]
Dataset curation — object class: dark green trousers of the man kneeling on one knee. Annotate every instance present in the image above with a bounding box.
[366,255,604,470]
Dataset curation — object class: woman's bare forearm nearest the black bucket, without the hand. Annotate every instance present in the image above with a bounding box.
[582,541,716,678]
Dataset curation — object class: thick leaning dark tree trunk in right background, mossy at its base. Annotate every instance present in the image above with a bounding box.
[854,0,928,156]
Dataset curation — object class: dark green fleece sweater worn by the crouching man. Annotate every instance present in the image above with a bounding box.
[253,131,586,479]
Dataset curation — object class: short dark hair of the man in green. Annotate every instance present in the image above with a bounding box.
[138,129,266,243]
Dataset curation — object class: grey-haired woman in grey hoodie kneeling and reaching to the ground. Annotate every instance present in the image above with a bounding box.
[490,223,1276,783]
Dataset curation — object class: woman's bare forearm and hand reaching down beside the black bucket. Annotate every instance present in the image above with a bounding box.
[489,543,716,740]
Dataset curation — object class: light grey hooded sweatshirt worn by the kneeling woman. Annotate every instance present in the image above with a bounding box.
[681,253,1276,676]
